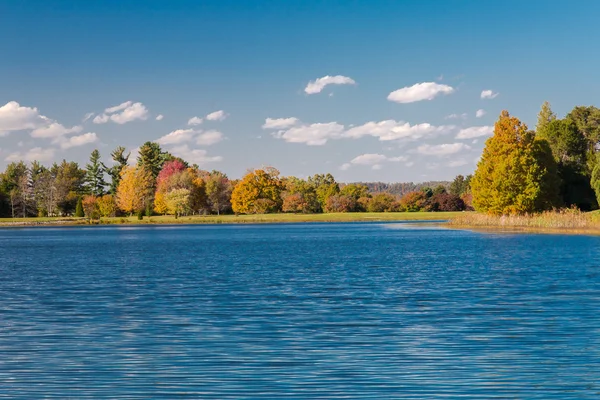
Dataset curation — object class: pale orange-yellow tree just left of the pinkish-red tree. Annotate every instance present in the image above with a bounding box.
[117,166,154,214]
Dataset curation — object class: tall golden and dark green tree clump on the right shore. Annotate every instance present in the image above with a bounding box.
[470,102,600,215]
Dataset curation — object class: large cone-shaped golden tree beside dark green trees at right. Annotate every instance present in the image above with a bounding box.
[471,111,559,214]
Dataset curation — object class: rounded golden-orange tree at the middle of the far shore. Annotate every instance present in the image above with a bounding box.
[231,167,284,214]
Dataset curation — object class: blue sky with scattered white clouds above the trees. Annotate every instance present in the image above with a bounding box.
[0,0,600,182]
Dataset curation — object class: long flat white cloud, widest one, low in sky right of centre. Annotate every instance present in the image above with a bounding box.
[343,120,454,141]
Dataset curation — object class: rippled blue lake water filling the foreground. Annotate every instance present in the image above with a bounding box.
[0,223,600,399]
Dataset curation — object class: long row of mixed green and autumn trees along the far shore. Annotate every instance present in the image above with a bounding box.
[0,142,471,218]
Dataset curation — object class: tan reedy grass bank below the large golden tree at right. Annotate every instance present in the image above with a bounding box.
[448,210,600,234]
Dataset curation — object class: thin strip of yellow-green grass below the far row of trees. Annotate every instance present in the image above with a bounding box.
[0,212,461,226]
